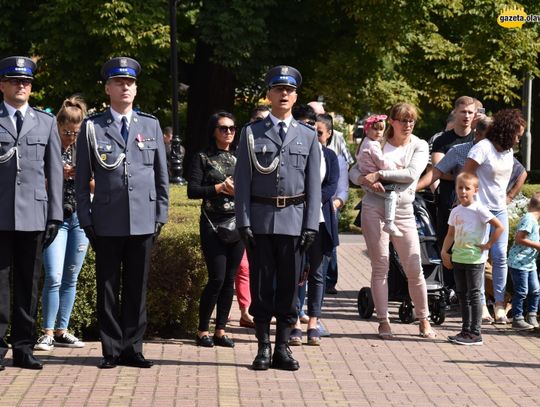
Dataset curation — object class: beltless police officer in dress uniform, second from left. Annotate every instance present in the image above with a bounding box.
[75,57,169,369]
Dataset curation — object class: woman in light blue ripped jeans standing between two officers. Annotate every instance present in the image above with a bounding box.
[35,96,88,351]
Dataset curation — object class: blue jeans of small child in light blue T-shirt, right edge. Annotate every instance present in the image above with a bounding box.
[508,267,540,318]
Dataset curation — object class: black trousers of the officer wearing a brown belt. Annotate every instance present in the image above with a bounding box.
[248,235,302,324]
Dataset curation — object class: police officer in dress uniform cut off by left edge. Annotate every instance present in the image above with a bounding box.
[0,56,63,370]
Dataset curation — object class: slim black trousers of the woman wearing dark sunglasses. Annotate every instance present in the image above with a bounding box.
[198,219,244,331]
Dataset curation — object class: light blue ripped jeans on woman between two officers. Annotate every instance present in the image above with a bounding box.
[42,213,88,329]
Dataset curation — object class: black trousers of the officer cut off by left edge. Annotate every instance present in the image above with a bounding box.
[0,231,44,361]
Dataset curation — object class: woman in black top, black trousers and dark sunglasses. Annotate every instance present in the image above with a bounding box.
[188,111,244,348]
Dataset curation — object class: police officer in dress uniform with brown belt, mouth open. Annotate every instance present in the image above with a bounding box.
[234,65,321,370]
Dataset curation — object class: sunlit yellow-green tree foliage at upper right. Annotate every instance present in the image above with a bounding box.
[315,0,540,119]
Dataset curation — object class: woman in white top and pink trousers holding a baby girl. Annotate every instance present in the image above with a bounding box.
[349,103,437,339]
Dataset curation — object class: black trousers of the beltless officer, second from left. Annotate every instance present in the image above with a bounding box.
[95,234,153,357]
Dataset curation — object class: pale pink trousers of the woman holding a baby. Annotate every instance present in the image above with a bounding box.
[362,203,429,319]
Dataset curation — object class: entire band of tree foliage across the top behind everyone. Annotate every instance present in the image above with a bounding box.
[0,0,540,142]
